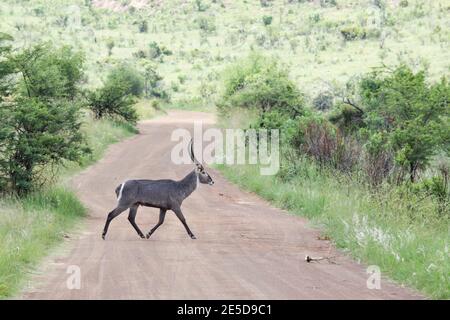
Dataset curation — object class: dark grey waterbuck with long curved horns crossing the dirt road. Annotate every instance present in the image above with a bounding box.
[102,140,214,240]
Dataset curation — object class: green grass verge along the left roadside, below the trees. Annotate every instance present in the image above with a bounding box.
[0,114,137,298]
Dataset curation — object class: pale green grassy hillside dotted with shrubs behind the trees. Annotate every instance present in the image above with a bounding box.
[0,0,450,102]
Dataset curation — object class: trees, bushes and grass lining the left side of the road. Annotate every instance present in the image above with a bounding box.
[0,21,144,297]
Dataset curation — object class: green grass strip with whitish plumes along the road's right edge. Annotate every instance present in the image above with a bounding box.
[218,162,450,299]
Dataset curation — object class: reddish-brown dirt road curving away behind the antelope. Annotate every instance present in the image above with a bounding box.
[23,111,420,299]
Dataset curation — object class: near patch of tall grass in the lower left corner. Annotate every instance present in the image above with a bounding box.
[0,186,86,298]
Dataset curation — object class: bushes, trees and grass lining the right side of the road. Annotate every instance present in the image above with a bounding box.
[218,54,450,297]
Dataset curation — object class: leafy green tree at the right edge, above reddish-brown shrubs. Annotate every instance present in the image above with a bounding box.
[361,65,450,182]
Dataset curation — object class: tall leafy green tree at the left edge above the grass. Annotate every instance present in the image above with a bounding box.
[0,44,89,195]
